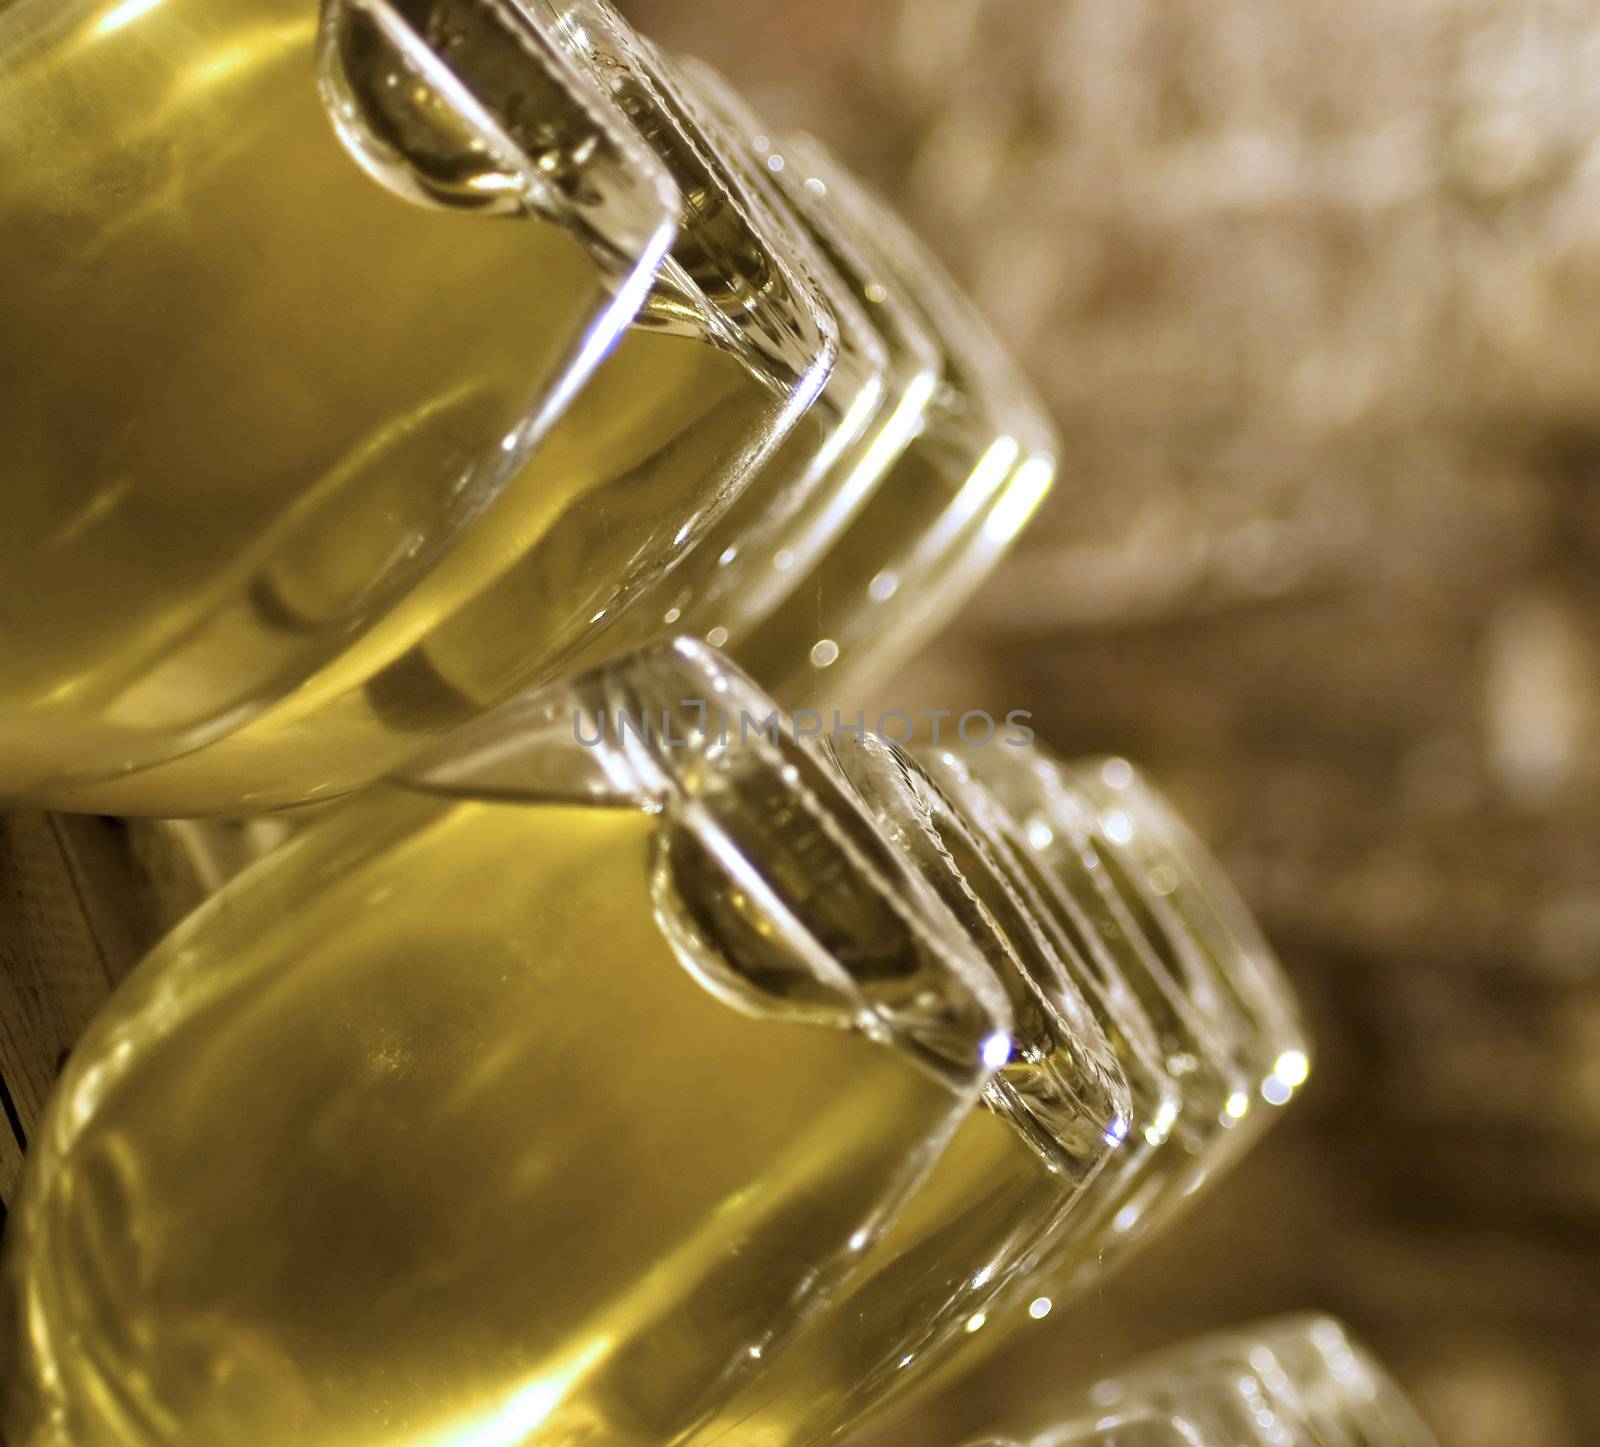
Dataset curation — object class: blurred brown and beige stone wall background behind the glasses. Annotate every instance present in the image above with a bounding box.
[624,0,1600,1447]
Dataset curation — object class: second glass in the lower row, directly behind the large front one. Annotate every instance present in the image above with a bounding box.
[690,740,1142,1447]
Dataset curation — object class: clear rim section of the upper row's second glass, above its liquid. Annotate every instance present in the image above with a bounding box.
[524,0,840,419]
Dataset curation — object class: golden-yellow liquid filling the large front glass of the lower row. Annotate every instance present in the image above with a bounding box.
[0,792,966,1447]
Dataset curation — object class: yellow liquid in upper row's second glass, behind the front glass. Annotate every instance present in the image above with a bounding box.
[76,325,793,813]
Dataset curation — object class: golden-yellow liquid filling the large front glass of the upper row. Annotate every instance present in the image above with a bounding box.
[0,0,620,796]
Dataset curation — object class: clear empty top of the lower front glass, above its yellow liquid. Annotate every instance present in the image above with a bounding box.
[400,640,1013,1088]
